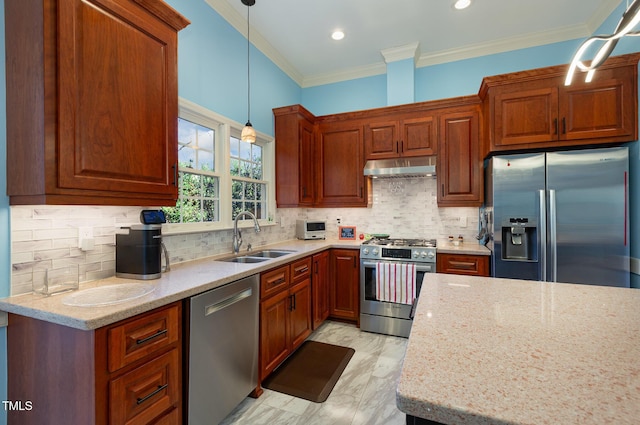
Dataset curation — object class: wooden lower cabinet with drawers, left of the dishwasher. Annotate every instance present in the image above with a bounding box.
[7,302,182,425]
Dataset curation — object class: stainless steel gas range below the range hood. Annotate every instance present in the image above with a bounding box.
[360,238,436,337]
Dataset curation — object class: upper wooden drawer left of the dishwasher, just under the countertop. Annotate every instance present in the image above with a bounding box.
[108,304,180,372]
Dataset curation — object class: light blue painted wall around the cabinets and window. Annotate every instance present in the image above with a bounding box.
[0,0,640,424]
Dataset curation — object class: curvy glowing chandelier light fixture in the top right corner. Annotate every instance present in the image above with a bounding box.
[564,0,640,86]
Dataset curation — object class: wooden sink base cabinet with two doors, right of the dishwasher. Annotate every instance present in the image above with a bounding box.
[259,257,312,382]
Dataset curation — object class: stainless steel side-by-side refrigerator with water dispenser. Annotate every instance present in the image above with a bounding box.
[481,147,630,287]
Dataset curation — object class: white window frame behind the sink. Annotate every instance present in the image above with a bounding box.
[162,97,276,235]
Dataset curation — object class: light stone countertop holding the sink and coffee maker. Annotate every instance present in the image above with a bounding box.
[0,240,361,330]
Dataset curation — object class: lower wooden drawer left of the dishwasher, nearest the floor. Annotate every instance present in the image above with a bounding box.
[109,349,180,425]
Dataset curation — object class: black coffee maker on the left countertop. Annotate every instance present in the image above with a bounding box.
[116,210,169,280]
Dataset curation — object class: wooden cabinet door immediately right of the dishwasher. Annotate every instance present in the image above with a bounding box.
[260,290,290,380]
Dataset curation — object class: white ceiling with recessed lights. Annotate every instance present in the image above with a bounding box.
[204,0,630,87]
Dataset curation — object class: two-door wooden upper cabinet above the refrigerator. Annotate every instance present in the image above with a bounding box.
[480,54,638,151]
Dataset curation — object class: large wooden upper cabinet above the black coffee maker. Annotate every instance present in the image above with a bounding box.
[5,0,189,205]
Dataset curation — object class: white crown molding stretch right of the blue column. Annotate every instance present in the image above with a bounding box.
[416,25,591,68]
